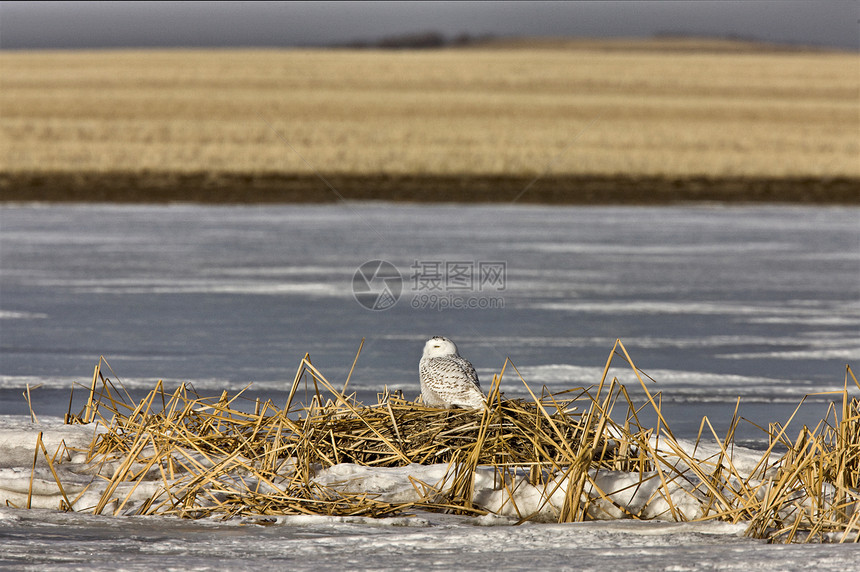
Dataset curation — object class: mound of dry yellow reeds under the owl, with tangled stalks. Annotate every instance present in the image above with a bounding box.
[23,341,860,542]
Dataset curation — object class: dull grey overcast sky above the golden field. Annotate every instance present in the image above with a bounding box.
[0,0,860,50]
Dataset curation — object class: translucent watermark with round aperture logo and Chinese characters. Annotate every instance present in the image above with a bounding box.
[352,260,508,311]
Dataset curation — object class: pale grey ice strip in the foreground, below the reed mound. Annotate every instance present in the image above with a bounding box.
[0,502,860,572]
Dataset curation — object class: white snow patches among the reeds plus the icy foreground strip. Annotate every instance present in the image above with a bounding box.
[0,416,860,571]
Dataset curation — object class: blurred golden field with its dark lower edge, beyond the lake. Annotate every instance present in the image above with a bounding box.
[0,38,860,202]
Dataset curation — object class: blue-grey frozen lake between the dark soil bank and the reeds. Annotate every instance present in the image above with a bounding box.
[0,204,860,438]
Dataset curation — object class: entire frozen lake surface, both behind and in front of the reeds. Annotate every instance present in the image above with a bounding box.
[0,204,860,570]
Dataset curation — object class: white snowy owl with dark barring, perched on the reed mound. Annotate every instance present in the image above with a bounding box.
[418,336,484,409]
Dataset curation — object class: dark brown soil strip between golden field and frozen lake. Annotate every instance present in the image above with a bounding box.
[0,172,860,204]
